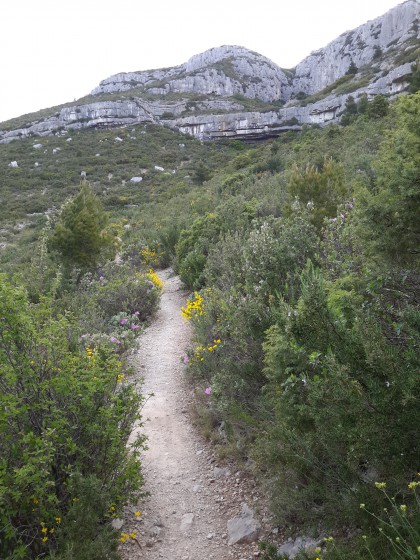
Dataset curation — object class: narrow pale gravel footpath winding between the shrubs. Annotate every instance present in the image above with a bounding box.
[121,270,272,560]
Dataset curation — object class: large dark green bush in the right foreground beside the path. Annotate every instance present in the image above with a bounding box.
[259,266,419,528]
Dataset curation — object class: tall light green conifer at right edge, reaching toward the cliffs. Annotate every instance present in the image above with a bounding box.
[359,93,420,263]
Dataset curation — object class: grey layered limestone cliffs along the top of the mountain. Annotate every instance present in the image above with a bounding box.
[0,0,420,142]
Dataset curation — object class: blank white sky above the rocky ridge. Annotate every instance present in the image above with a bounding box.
[0,0,400,122]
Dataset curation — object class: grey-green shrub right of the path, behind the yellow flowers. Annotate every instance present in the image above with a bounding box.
[185,211,318,440]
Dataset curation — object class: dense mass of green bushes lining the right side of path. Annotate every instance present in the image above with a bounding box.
[181,94,420,560]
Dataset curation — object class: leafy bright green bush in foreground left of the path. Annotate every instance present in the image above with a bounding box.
[0,277,143,560]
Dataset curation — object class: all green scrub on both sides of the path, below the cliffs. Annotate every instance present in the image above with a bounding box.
[0,93,420,560]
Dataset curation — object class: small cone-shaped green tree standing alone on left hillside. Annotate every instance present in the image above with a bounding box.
[49,183,117,273]
